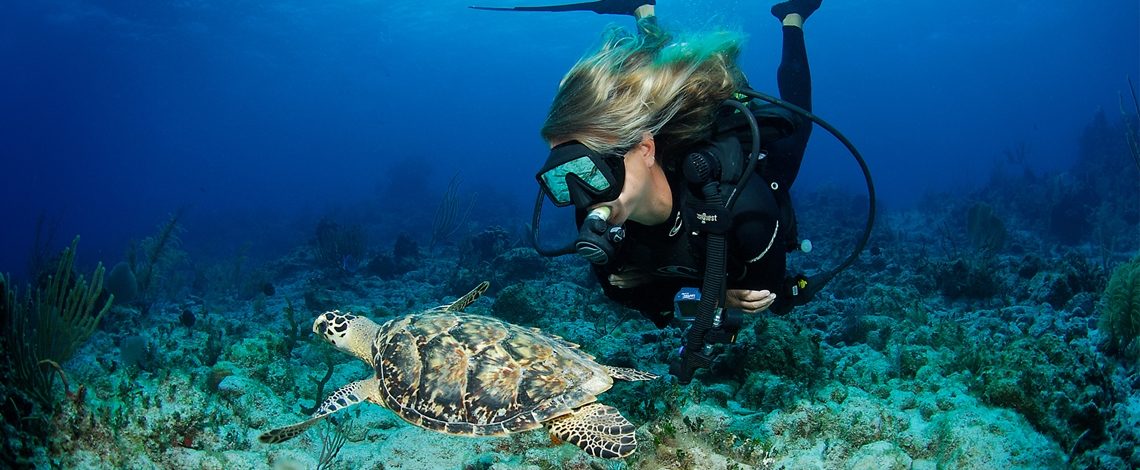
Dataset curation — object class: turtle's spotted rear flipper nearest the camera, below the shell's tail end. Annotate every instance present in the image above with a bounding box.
[546,403,637,459]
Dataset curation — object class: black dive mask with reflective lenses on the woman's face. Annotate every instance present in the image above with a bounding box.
[535,140,626,209]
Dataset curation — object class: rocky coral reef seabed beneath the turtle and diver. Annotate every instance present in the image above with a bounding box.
[0,105,1140,470]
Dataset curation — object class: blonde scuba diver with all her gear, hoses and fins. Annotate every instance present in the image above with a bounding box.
[473,0,873,383]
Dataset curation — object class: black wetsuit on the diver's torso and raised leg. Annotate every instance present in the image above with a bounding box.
[579,26,812,326]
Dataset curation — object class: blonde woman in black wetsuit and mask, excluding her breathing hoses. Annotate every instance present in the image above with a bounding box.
[529,0,822,327]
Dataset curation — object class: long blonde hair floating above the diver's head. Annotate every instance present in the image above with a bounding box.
[542,21,743,160]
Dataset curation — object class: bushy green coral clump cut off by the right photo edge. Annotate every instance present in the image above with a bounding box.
[1100,257,1140,360]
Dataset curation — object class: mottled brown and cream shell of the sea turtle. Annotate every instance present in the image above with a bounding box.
[373,310,613,436]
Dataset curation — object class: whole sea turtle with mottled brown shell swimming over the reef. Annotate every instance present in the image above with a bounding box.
[260,282,657,459]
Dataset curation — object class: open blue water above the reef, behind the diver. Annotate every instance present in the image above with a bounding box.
[0,0,1140,279]
